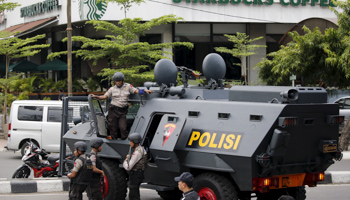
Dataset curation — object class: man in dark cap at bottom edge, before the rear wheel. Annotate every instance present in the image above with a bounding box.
[174,172,200,200]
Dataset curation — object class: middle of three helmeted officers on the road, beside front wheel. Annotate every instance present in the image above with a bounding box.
[87,138,105,200]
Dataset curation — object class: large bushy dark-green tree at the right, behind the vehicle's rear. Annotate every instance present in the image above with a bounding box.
[257,26,350,88]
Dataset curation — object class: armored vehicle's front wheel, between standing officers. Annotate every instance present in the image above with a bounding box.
[101,159,127,200]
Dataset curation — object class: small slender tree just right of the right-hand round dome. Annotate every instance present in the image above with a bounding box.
[215,32,266,84]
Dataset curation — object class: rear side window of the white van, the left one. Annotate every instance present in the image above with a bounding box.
[18,106,43,122]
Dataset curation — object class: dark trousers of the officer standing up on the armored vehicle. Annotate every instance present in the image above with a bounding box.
[108,107,128,140]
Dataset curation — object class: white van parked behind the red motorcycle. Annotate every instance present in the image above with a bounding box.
[7,100,73,155]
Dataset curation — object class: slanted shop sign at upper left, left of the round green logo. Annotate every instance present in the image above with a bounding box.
[21,0,59,17]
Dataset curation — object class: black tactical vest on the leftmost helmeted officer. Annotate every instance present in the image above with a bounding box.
[74,154,93,185]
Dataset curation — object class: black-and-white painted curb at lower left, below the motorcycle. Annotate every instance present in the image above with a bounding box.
[0,178,70,194]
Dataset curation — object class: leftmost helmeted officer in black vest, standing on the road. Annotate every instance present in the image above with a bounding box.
[67,141,93,200]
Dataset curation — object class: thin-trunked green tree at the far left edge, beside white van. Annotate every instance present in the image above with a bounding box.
[0,31,50,128]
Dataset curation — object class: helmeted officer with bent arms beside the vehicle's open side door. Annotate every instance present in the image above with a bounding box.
[123,133,147,200]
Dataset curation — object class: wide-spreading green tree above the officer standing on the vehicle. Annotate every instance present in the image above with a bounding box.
[48,3,193,85]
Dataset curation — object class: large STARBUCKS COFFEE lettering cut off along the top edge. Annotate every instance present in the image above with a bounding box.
[172,0,335,7]
